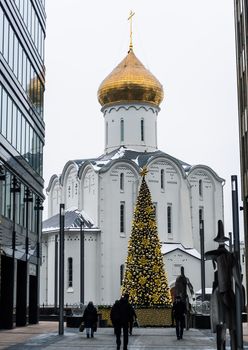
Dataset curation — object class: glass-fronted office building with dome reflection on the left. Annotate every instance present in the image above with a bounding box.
[0,0,46,329]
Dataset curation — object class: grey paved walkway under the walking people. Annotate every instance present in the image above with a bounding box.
[0,322,248,350]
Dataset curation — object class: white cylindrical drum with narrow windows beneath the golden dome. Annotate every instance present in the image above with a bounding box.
[104,104,157,153]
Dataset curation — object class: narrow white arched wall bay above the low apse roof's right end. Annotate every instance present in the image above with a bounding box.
[83,166,98,225]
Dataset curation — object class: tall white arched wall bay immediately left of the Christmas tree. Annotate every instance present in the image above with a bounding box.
[99,164,138,304]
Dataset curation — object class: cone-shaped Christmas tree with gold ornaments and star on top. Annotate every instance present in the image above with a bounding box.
[122,168,172,306]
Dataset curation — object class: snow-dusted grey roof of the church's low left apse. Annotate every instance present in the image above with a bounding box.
[42,208,97,232]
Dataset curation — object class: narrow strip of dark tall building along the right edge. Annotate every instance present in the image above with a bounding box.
[234,0,248,300]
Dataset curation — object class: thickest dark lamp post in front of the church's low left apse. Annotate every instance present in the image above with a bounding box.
[59,204,65,335]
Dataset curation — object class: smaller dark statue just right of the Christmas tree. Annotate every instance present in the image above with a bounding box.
[174,266,194,330]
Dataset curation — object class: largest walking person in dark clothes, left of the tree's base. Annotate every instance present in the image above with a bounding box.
[110,296,132,350]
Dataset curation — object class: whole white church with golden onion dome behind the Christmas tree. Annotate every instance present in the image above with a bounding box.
[40,39,224,305]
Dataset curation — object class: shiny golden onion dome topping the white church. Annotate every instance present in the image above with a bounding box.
[97,49,164,106]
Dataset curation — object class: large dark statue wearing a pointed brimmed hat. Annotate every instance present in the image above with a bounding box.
[205,220,242,350]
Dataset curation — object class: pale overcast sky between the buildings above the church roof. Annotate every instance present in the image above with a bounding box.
[44,0,241,237]
